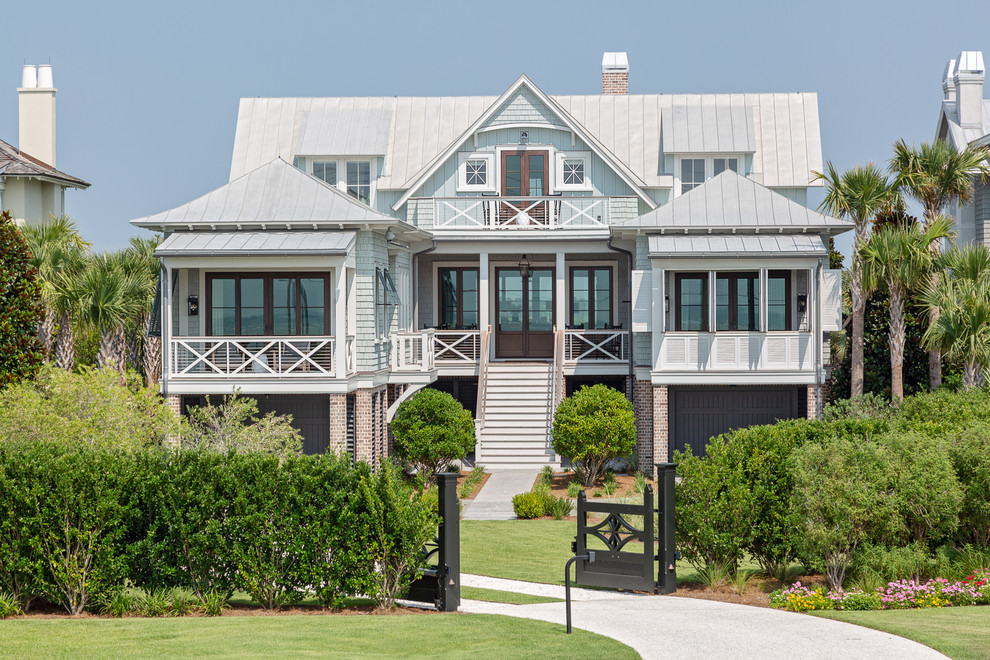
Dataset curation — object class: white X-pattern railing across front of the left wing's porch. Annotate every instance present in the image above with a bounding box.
[168,337,336,378]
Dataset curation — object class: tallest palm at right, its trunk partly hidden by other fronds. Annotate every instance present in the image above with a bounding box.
[890,140,990,390]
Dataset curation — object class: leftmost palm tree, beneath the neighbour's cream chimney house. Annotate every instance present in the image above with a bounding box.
[21,215,90,362]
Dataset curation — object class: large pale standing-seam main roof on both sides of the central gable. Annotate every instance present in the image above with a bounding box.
[230,81,823,190]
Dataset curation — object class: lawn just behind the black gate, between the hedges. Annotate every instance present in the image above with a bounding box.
[461,520,720,584]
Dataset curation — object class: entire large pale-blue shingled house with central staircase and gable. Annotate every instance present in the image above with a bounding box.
[132,53,851,469]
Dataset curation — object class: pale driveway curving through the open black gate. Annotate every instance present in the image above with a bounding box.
[461,575,945,660]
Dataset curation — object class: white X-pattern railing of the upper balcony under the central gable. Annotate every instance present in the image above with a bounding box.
[432,196,609,230]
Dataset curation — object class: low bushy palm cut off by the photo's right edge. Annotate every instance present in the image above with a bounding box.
[921,244,990,389]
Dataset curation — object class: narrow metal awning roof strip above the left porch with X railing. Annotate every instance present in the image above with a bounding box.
[155,231,355,257]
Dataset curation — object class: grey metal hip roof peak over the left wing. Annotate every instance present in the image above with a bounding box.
[131,159,396,229]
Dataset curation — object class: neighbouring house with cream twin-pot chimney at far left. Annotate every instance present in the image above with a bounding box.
[0,64,89,223]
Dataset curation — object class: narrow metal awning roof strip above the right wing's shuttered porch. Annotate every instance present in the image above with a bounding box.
[650,234,828,258]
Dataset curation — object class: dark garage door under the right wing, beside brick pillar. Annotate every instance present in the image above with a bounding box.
[668,386,808,458]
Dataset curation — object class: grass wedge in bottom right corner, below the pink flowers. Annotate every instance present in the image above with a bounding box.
[815,607,990,660]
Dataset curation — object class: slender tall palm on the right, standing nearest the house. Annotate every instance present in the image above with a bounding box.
[814,163,896,396]
